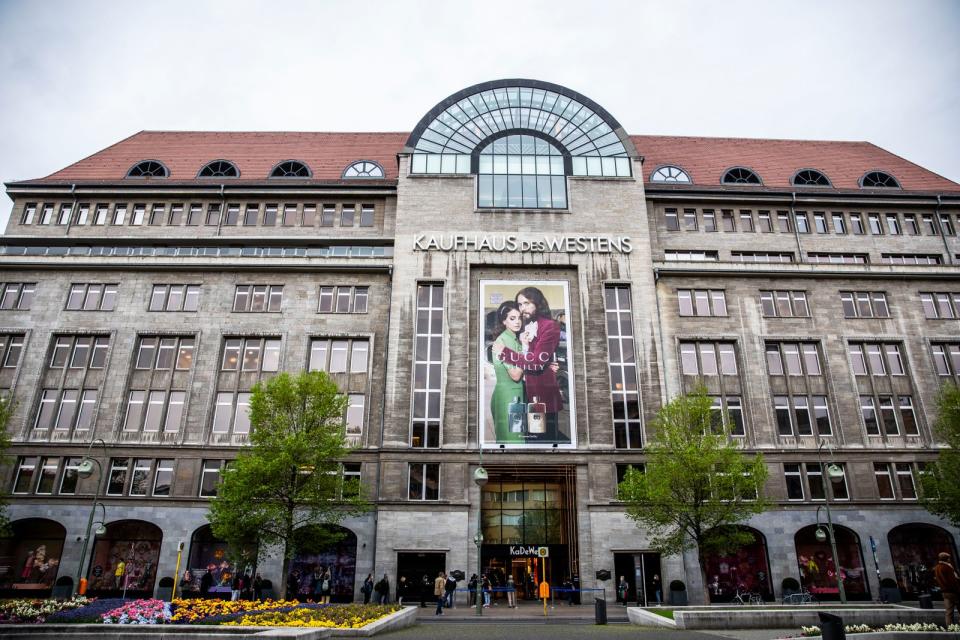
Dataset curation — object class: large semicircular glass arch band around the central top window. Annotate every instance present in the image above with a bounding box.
[405,80,637,176]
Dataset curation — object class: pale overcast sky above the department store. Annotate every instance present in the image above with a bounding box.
[0,0,960,226]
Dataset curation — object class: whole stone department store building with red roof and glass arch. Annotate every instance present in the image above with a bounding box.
[0,80,960,601]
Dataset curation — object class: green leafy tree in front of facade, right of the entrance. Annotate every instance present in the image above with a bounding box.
[619,387,768,601]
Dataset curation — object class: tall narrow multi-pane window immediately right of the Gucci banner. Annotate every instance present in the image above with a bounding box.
[603,285,643,449]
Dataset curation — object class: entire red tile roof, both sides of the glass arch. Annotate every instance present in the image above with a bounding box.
[11,131,960,192]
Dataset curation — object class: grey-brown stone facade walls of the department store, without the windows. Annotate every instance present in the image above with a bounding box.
[0,80,960,599]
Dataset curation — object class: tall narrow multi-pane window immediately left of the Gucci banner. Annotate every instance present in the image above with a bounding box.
[411,283,444,447]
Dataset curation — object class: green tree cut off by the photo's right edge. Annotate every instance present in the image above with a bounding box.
[920,383,960,526]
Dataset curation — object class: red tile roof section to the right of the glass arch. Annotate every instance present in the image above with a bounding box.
[630,136,960,191]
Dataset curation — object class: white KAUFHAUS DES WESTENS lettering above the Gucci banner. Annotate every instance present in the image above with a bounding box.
[413,233,633,253]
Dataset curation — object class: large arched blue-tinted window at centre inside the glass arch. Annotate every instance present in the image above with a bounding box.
[477,135,567,209]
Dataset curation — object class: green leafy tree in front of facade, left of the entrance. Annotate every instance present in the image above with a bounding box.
[208,371,369,594]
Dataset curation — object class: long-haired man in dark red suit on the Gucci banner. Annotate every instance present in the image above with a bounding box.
[493,287,563,442]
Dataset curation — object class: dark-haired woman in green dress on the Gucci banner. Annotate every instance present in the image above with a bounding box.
[490,300,526,444]
